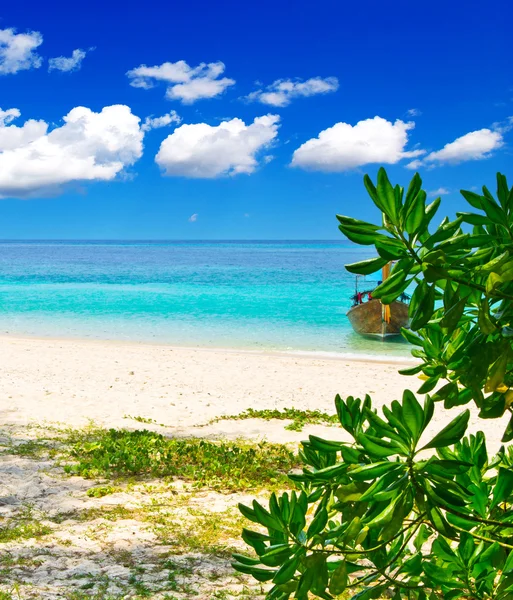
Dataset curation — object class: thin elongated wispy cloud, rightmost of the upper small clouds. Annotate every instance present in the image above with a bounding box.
[246,77,338,106]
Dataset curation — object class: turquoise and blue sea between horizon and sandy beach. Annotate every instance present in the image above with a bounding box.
[0,241,409,356]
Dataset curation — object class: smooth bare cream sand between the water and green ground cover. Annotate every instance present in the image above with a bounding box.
[0,337,503,449]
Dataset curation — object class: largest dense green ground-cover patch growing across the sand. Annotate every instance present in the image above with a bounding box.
[65,429,300,491]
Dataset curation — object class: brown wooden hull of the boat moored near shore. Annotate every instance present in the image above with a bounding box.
[347,300,409,338]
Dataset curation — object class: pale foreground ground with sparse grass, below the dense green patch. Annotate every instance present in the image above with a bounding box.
[0,427,270,600]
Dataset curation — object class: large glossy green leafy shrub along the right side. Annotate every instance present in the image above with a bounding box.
[234,169,513,600]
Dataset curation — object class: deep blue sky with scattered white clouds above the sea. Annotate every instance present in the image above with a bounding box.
[0,0,513,240]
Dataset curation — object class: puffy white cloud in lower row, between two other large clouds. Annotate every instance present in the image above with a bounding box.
[155,115,280,178]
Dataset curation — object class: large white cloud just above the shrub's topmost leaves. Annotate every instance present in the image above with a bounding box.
[291,117,424,172]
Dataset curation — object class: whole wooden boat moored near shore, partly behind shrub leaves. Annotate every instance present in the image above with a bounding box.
[347,265,409,339]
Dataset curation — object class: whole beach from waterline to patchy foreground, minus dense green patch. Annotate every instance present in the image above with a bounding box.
[0,336,505,600]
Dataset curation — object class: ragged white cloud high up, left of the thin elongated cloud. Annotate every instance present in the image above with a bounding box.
[127,60,235,104]
